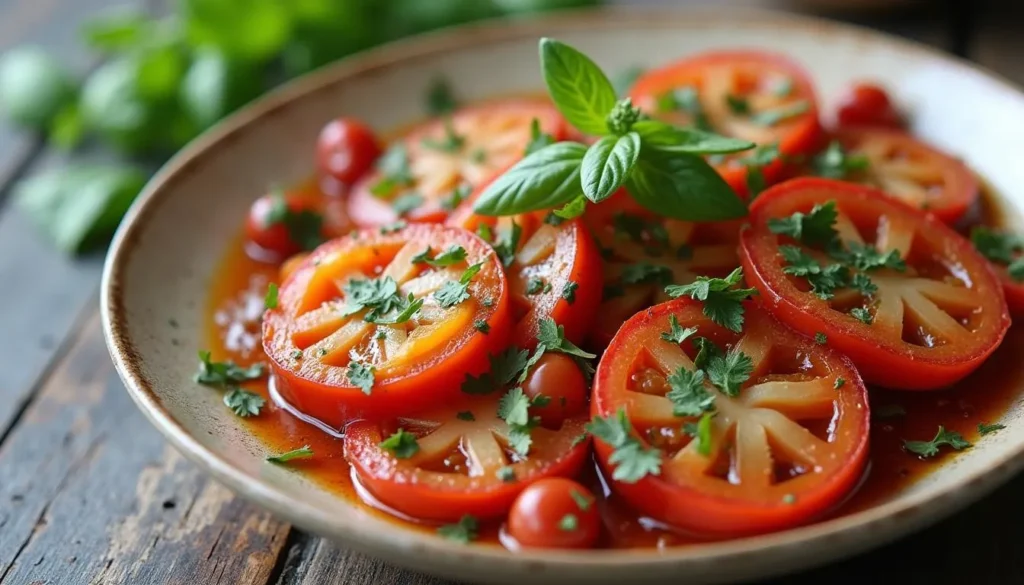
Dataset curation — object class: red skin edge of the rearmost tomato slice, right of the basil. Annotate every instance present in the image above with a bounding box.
[630,50,824,197]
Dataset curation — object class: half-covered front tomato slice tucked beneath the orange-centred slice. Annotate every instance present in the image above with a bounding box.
[345,396,590,521]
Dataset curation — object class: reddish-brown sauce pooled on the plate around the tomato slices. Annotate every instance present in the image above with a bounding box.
[205,178,1024,548]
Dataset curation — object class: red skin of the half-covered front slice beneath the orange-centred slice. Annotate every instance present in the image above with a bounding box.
[345,418,590,523]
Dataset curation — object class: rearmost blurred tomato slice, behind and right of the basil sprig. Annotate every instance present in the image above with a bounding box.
[630,51,821,194]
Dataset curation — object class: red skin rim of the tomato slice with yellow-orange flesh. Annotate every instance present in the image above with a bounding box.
[263,225,512,428]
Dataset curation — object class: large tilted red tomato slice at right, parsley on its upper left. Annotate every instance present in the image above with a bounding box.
[740,178,1010,389]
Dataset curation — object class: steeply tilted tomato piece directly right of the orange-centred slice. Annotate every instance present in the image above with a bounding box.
[449,176,601,349]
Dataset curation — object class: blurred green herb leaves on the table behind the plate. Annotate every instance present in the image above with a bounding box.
[0,0,599,253]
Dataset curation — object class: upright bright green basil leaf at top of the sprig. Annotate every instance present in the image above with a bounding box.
[541,38,615,135]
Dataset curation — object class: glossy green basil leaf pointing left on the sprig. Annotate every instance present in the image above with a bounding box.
[473,142,587,215]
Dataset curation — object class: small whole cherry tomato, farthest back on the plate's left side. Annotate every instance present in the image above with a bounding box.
[316,118,381,184]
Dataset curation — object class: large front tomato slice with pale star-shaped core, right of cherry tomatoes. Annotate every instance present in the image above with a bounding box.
[591,299,869,535]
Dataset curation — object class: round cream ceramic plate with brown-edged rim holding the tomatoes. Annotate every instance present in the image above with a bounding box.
[101,9,1024,585]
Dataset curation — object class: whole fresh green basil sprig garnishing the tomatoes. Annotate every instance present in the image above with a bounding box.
[473,38,755,221]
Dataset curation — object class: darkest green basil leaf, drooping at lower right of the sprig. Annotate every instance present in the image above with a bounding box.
[626,149,746,221]
